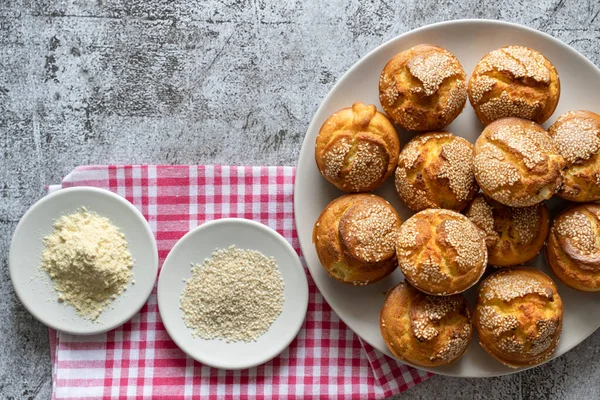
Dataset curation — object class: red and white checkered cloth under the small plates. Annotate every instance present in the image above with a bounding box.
[50,166,430,399]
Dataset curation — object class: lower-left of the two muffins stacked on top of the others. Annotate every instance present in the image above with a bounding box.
[396,209,487,296]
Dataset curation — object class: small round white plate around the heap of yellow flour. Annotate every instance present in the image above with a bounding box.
[8,186,158,335]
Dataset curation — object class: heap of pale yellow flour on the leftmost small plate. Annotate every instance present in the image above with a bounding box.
[40,208,135,320]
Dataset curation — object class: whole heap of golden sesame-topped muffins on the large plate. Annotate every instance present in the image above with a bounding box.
[313,45,600,368]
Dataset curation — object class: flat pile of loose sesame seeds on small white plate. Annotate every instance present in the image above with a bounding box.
[180,246,284,342]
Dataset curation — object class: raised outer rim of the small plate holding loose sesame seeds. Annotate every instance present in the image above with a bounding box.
[156,217,310,371]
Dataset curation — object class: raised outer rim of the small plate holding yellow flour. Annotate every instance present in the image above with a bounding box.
[8,185,158,336]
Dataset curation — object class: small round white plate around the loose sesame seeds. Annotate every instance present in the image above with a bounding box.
[158,218,308,369]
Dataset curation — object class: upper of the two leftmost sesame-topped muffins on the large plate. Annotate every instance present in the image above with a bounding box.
[315,103,400,192]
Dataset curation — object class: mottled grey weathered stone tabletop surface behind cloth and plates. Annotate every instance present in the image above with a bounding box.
[0,0,600,399]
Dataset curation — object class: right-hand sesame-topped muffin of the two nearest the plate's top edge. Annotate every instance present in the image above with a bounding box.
[469,46,560,125]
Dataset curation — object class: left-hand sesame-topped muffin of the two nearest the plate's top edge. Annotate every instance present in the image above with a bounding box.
[379,44,467,131]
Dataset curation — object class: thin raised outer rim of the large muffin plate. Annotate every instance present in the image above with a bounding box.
[294,18,600,378]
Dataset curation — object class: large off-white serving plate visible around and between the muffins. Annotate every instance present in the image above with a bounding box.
[295,20,600,377]
